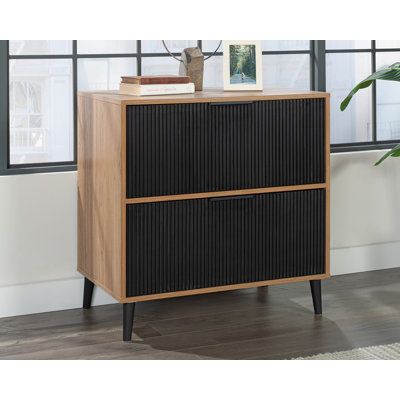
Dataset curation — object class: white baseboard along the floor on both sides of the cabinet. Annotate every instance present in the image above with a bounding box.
[0,242,400,317]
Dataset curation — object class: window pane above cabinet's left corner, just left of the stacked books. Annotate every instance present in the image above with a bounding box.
[78,57,136,90]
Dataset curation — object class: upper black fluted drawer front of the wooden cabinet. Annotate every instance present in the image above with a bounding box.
[126,99,325,197]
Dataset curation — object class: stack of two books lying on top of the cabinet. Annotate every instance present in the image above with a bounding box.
[119,75,194,96]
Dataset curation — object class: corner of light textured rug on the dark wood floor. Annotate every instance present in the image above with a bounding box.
[296,343,400,360]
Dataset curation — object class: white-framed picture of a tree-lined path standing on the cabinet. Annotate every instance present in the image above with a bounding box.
[224,40,263,90]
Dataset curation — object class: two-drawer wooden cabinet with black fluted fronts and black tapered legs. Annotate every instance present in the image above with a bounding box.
[78,91,329,340]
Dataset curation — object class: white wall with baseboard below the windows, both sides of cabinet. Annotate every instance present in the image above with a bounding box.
[0,151,400,317]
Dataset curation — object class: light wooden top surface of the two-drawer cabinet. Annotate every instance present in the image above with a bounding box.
[78,89,329,105]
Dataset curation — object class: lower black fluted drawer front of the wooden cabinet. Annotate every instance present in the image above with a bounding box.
[126,190,325,296]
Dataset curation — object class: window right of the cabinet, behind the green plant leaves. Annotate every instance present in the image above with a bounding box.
[325,40,400,150]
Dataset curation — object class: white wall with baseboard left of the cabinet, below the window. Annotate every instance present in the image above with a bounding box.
[0,172,117,317]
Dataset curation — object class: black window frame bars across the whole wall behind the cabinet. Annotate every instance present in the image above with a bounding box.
[0,40,400,176]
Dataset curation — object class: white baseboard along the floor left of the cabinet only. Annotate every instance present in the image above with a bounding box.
[0,278,116,318]
